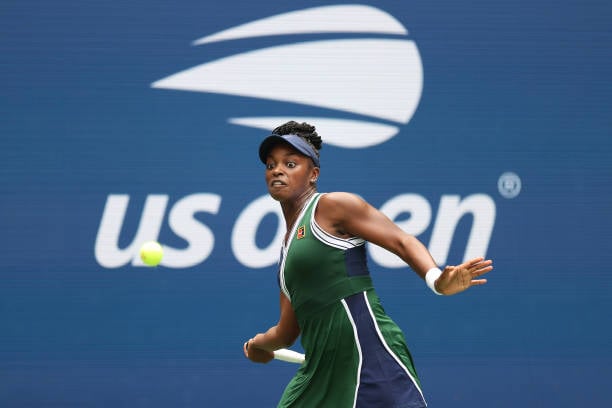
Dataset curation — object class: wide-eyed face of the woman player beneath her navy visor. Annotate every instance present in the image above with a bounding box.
[266,143,319,201]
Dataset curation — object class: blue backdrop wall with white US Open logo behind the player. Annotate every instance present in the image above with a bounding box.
[0,0,612,407]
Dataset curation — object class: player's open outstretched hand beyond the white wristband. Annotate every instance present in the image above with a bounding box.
[435,257,493,295]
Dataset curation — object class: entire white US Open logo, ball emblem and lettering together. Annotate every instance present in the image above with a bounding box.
[95,5,498,268]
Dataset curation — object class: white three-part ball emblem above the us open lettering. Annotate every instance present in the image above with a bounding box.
[151,5,423,148]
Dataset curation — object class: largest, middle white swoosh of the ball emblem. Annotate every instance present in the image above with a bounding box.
[152,39,423,123]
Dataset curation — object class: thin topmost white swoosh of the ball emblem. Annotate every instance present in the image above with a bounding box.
[193,4,408,45]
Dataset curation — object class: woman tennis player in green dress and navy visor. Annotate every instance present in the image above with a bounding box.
[244,121,493,408]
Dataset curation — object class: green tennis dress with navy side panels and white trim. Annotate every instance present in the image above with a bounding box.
[278,194,427,408]
